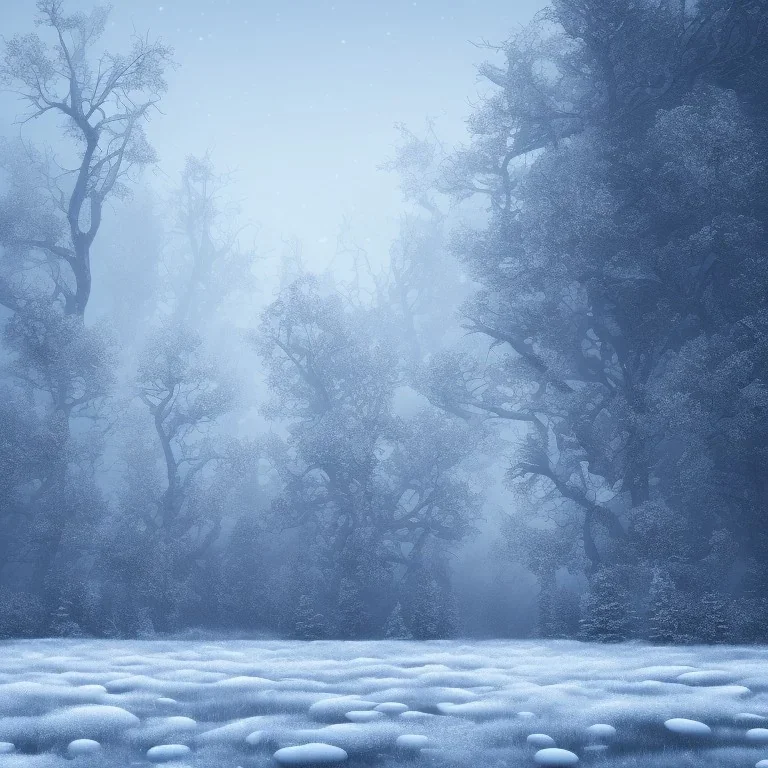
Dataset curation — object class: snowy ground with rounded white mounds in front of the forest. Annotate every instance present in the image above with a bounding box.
[0,641,768,768]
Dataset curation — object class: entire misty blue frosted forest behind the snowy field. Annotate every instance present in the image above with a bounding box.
[0,0,768,644]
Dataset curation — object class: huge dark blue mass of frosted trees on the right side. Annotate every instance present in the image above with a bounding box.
[425,0,768,642]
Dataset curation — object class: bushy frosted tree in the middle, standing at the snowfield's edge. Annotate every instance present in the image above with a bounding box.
[257,276,477,638]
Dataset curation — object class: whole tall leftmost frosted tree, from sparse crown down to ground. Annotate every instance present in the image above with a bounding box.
[0,0,170,631]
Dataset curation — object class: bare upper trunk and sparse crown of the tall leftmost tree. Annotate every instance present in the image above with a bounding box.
[0,0,171,317]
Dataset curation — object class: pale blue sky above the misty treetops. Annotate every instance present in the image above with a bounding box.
[0,0,541,270]
